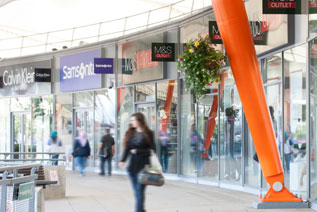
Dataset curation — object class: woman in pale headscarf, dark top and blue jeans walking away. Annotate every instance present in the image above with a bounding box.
[74,131,90,176]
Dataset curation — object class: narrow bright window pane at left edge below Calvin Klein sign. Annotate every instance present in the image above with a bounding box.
[0,99,10,159]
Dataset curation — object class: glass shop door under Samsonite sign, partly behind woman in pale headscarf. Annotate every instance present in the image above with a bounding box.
[73,108,96,166]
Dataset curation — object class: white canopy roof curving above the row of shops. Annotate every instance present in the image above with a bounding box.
[0,0,211,58]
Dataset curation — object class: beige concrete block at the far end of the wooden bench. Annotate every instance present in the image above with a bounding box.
[44,166,66,200]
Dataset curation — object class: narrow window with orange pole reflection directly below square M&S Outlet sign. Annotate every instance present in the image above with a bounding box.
[156,80,177,174]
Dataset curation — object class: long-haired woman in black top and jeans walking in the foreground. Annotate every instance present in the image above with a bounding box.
[120,112,155,212]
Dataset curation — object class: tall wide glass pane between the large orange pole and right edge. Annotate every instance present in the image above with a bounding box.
[284,46,307,197]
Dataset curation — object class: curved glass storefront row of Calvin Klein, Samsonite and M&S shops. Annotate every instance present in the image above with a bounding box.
[0,1,317,205]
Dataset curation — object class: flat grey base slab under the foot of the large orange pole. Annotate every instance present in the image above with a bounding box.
[252,201,309,209]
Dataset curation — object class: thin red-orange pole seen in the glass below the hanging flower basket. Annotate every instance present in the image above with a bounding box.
[201,74,226,158]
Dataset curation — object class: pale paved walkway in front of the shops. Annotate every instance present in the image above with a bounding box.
[45,172,313,212]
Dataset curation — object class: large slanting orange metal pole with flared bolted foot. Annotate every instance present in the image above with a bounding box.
[212,0,302,202]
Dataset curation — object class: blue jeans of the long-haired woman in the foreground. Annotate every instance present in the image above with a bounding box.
[128,172,146,212]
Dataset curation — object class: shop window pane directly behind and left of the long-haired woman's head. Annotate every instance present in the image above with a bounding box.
[117,87,134,166]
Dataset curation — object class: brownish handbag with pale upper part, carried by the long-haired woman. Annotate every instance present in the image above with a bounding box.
[138,150,164,186]
